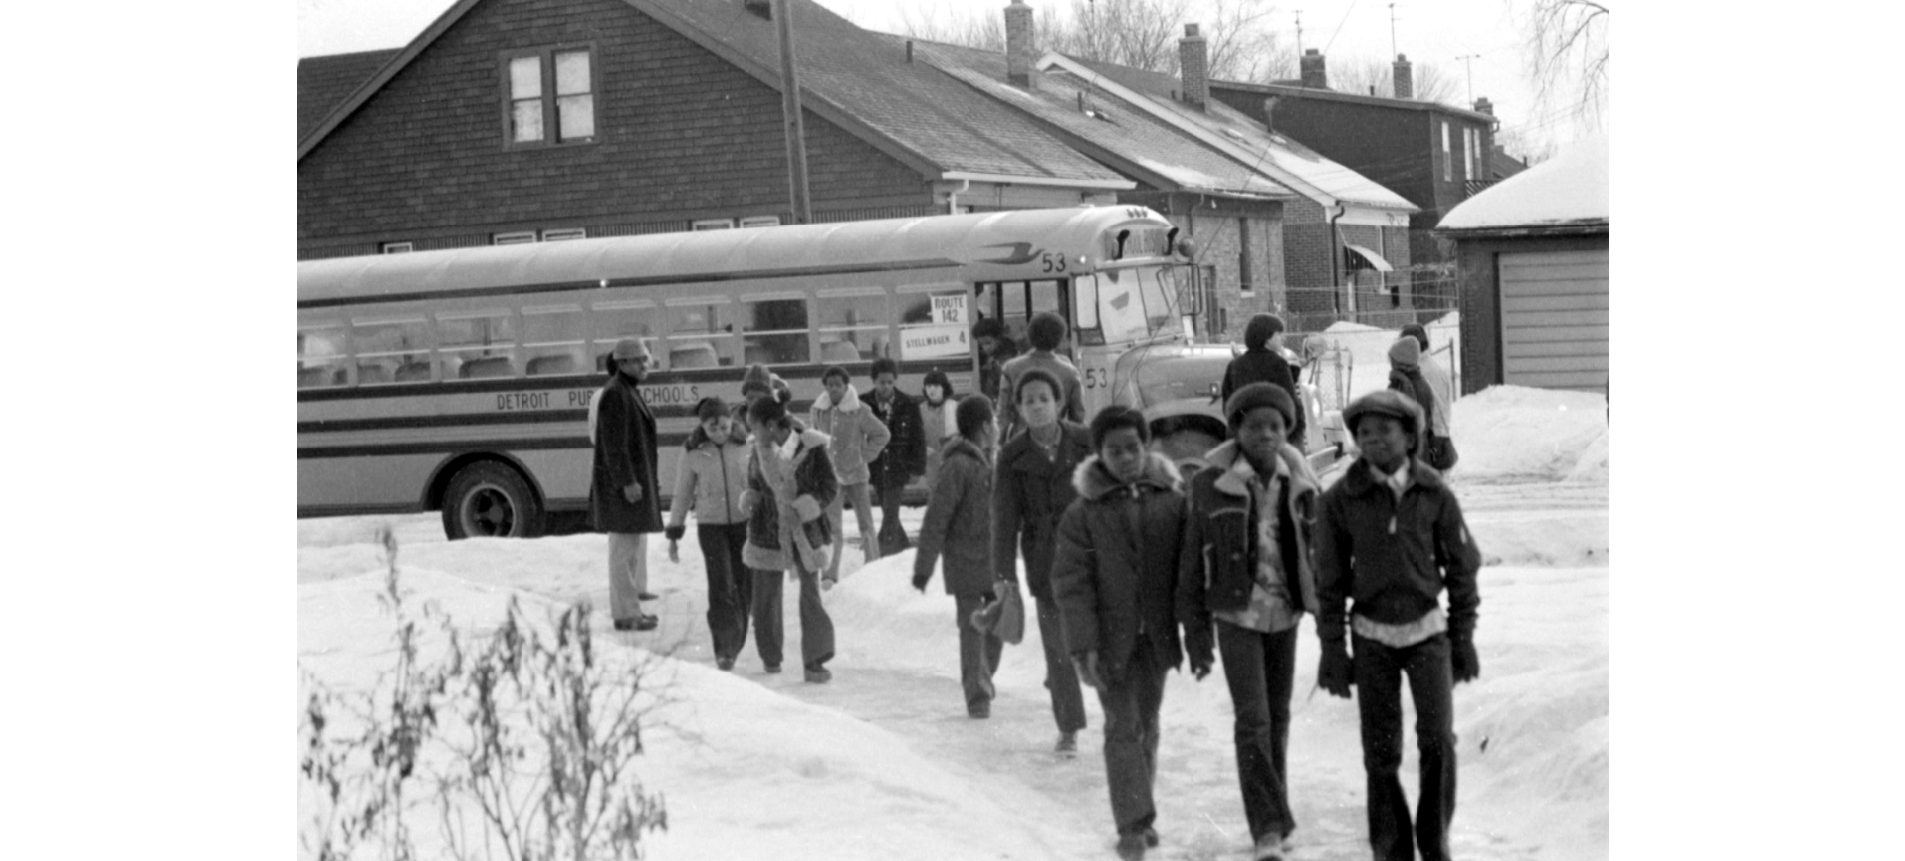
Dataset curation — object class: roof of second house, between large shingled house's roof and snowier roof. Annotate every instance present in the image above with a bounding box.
[878,34,1295,200]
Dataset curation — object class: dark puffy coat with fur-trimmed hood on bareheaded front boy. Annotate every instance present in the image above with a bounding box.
[1052,451,1191,684]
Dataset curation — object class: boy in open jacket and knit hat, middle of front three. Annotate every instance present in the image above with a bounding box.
[1177,383,1316,861]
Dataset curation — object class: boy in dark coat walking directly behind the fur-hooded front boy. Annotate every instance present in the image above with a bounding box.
[993,368,1092,756]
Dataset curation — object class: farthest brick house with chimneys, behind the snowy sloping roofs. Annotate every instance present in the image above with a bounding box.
[1210,48,1497,323]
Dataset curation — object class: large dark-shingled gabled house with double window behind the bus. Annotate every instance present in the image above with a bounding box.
[297,0,1135,259]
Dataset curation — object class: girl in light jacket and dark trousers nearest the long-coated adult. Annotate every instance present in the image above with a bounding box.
[667,398,754,671]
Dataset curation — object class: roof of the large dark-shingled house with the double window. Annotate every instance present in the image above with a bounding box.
[297,0,1132,189]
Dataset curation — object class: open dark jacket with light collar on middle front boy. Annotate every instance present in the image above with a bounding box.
[1177,440,1318,627]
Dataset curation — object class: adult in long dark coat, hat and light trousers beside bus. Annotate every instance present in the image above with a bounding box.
[589,337,661,631]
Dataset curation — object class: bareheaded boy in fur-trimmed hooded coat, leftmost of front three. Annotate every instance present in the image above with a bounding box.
[1052,406,1189,861]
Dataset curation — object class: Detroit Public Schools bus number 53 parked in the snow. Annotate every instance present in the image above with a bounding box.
[297,206,1231,539]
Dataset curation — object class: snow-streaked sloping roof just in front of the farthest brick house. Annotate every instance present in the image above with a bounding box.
[1038,53,1417,211]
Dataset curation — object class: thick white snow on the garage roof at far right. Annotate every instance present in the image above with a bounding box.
[1436,135,1608,230]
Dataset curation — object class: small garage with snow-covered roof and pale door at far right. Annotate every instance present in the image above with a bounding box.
[1436,137,1608,392]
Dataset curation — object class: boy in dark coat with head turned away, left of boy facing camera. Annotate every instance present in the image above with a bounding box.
[912,394,1006,718]
